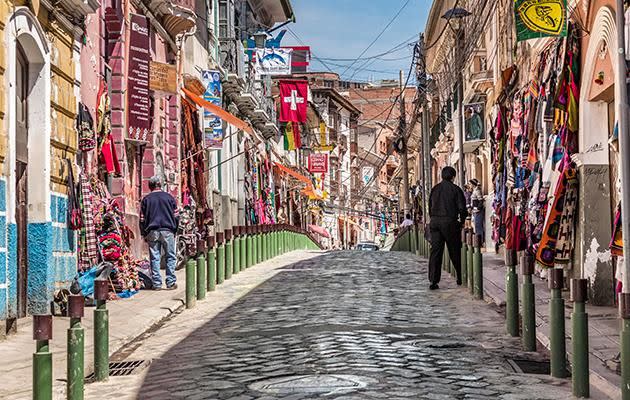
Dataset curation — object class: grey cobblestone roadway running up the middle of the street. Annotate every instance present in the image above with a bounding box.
[86,252,572,400]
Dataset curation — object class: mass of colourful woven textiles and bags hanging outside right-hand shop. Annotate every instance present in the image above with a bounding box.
[492,27,580,268]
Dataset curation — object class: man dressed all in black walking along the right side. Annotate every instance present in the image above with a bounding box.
[429,167,468,290]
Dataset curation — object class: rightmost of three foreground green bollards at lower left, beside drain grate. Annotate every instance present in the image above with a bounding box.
[94,280,109,382]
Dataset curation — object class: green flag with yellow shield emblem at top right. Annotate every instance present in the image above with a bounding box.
[514,0,567,42]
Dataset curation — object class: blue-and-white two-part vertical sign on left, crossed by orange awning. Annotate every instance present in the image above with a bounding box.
[201,71,223,150]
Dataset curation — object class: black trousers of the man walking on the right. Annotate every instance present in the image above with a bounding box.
[429,220,462,284]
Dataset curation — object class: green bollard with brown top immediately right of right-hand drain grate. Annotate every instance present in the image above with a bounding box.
[549,268,567,378]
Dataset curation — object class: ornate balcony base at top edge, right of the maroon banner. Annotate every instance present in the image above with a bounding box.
[148,0,197,37]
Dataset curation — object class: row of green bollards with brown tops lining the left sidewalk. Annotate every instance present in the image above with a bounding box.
[33,225,320,400]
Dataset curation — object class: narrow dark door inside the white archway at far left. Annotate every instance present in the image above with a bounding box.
[15,46,28,318]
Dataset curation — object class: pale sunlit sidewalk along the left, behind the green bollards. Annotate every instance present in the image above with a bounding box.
[0,251,319,400]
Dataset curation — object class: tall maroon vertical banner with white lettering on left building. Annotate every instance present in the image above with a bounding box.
[127,14,151,141]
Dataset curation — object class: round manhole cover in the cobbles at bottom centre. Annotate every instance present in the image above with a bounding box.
[250,375,377,394]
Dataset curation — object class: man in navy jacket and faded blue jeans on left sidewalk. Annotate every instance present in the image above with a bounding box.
[140,176,178,290]
